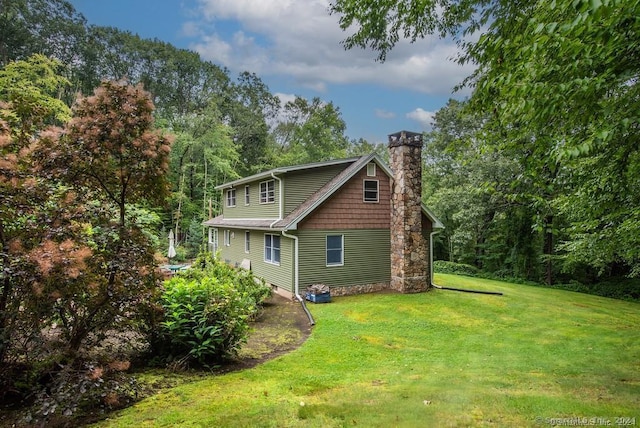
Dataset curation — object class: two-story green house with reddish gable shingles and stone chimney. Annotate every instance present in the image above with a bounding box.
[204,132,443,297]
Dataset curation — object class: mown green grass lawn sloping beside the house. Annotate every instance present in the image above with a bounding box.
[96,274,640,427]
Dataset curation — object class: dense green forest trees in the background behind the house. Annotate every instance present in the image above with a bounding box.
[0,0,640,283]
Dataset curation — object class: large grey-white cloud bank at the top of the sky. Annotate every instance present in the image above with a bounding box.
[184,0,472,95]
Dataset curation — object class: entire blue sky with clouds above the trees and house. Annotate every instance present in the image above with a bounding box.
[70,0,472,143]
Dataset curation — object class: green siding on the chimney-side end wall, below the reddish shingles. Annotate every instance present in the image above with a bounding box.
[298,229,391,292]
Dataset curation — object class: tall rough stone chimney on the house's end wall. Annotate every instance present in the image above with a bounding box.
[389,131,430,293]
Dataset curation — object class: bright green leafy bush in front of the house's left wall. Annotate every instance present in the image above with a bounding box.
[154,254,271,366]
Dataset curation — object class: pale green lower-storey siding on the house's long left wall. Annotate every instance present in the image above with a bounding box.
[219,228,294,292]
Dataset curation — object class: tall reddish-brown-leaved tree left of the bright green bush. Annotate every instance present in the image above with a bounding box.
[31,81,171,356]
